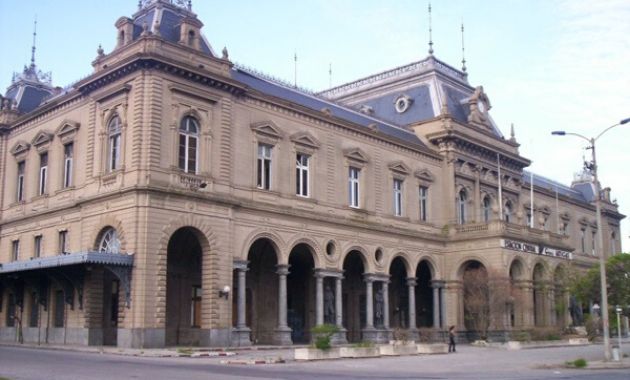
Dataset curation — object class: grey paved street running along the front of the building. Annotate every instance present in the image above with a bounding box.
[0,346,630,380]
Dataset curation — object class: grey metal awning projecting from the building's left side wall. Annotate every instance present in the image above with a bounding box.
[0,252,133,274]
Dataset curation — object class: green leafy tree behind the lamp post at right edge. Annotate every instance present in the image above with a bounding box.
[572,253,630,313]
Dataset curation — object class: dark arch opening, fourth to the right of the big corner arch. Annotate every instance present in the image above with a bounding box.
[389,257,409,329]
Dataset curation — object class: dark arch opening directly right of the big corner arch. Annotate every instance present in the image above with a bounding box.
[246,238,278,344]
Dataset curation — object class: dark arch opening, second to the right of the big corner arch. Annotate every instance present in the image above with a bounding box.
[287,244,315,343]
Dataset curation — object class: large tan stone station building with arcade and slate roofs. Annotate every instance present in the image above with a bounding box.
[0,0,623,347]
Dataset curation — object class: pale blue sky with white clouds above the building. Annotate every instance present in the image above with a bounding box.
[0,0,630,252]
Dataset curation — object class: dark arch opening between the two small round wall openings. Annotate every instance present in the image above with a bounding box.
[343,251,366,343]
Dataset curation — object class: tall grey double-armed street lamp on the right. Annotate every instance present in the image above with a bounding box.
[551,117,630,361]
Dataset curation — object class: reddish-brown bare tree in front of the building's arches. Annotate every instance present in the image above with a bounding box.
[463,267,514,340]
